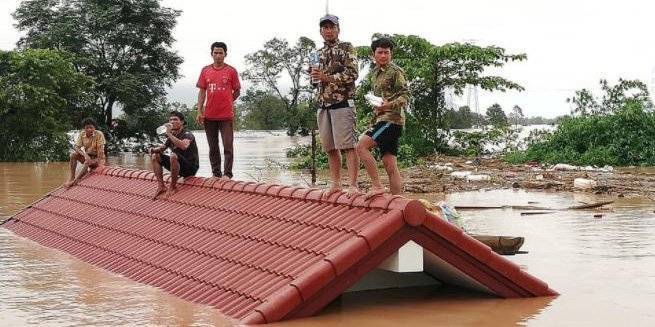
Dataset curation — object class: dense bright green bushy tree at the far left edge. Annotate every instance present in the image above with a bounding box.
[0,49,93,161]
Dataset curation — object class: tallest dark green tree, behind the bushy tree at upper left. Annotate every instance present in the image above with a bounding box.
[13,0,182,126]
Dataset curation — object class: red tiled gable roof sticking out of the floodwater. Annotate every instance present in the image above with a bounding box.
[5,167,556,323]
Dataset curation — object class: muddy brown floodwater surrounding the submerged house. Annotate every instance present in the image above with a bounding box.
[0,132,655,326]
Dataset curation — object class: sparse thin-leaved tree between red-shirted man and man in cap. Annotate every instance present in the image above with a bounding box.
[243,37,316,135]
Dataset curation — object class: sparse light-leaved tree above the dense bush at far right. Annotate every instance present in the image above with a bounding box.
[566,78,653,116]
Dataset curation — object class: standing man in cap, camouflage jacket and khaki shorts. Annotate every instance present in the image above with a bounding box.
[311,15,359,198]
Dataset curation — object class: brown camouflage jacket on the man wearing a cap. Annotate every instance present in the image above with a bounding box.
[316,40,358,107]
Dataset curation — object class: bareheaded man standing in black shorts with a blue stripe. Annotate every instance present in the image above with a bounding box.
[357,38,409,197]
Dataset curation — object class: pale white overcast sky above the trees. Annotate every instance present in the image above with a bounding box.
[0,0,655,117]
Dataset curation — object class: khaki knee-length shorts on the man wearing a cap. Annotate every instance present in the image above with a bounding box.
[316,107,357,152]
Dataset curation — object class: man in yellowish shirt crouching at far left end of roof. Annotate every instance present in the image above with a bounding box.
[64,118,106,187]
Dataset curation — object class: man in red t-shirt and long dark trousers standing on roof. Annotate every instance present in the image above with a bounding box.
[196,42,241,178]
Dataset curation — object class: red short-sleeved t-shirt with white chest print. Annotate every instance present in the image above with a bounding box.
[196,65,241,120]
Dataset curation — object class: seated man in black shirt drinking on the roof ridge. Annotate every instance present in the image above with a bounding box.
[148,111,199,198]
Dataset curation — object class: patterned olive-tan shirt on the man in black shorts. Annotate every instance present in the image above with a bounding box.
[371,63,409,125]
